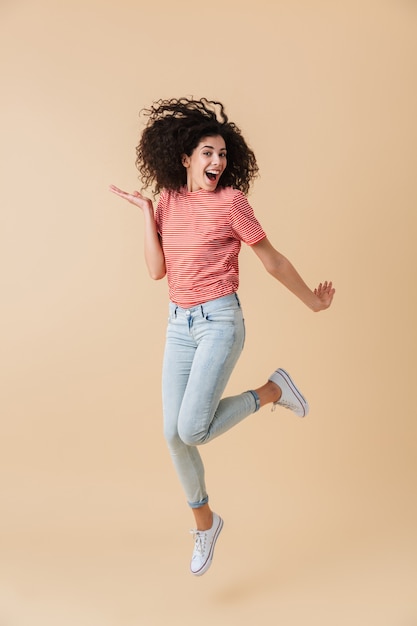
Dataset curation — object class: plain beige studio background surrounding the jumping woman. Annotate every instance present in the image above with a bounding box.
[0,0,417,626]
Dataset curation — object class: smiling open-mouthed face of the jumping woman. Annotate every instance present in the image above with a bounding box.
[182,135,227,191]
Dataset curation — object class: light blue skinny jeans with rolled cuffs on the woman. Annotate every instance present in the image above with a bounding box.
[162,293,259,508]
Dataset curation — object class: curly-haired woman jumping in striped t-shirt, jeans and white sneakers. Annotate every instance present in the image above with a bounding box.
[110,98,334,576]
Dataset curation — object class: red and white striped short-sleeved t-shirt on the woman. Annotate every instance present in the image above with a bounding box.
[155,187,266,308]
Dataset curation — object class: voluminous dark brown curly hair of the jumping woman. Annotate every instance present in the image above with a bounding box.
[136,98,259,195]
